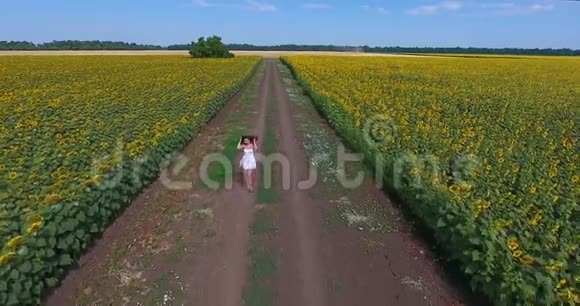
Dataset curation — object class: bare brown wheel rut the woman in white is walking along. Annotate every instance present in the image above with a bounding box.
[182,59,273,306]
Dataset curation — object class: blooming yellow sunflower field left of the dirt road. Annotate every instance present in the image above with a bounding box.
[0,56,259,305]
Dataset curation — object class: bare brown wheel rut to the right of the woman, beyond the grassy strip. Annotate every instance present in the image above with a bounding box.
[272,61,327,306]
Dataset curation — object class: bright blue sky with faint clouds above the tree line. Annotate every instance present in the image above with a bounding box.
[0,0,580,49]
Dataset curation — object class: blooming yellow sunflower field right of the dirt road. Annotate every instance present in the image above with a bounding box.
[283,56,580,305]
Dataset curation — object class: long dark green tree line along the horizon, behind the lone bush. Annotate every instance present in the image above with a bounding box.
[0,40,580,56]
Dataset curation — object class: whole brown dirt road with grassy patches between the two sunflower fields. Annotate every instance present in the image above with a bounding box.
[46,59,471,306]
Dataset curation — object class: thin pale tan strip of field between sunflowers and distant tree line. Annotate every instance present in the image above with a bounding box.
[0,50,426,58]
